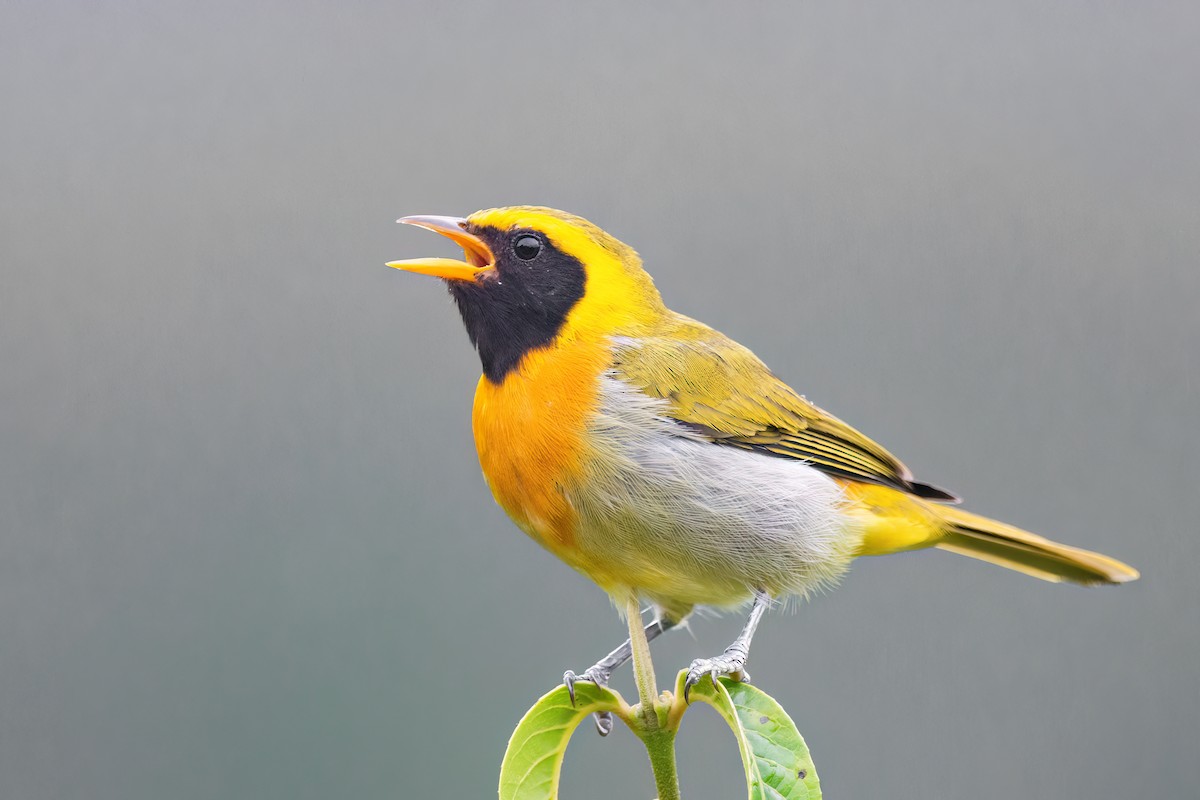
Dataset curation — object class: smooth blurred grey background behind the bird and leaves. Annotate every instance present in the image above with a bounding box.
[0,1,1200,800]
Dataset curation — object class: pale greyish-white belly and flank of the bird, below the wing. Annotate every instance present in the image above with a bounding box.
[566,377,862,608]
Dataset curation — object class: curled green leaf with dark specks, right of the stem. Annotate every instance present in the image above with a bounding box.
[676,670,821,800]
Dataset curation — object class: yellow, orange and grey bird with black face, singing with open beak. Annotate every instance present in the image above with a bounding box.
[388,206,1138,734]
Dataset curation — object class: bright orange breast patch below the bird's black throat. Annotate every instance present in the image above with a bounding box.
[472,342,608,561]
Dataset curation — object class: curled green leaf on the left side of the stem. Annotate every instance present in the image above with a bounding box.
[500,681,630,800]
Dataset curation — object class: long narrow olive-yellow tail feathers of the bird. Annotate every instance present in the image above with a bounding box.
[929,505,1138,584]
